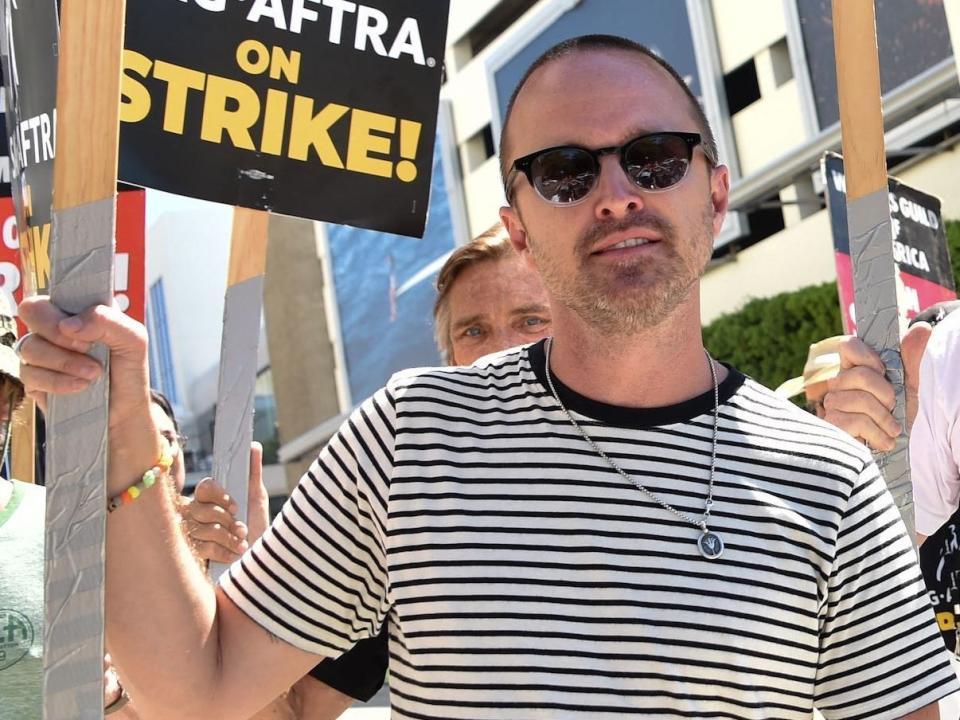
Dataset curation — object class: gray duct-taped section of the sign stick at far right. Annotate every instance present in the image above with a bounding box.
[847,188,915,539]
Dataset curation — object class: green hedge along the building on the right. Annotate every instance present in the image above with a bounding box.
[703,220,960,388]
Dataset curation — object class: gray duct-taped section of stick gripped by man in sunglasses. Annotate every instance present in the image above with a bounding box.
[43,198,116,720]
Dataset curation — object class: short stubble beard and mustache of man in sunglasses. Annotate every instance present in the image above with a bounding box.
[528,201,713,337]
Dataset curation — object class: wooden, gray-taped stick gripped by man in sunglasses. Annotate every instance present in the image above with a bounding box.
[43,0,126,720]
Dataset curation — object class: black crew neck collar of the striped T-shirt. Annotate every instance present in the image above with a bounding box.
[527,340,746,429]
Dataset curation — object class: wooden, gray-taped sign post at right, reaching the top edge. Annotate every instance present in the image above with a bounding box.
[833,0,915,539]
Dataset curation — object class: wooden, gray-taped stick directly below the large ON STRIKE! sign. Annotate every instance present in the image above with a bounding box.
[210,207,270,578]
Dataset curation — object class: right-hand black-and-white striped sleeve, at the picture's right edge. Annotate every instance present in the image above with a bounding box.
[815,462,960,720]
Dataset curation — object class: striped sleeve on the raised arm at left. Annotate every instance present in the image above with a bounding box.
[220,389,395,657]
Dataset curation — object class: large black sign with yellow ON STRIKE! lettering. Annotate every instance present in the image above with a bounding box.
[120,0,448,236]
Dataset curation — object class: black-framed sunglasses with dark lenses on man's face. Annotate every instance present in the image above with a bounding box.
[506,132,709,205]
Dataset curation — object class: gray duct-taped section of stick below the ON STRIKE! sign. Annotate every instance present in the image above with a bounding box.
[210,275,263,580]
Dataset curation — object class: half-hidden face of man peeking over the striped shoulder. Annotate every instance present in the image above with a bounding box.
[448,255,550,365]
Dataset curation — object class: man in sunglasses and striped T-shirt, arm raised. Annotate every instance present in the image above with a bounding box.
[15,36,957,720]
